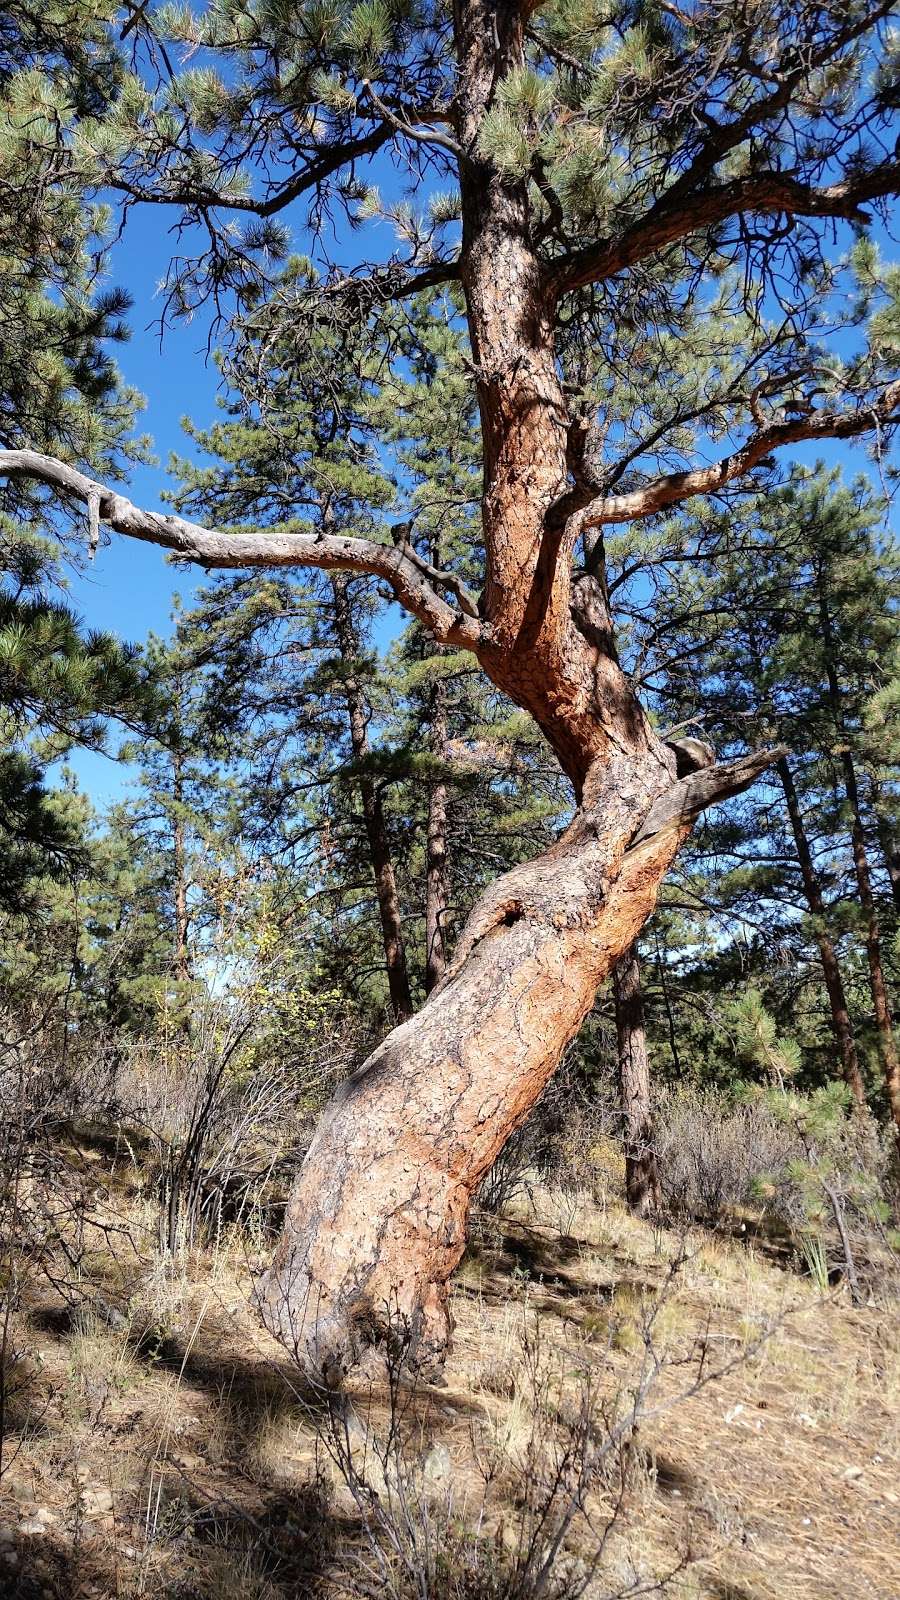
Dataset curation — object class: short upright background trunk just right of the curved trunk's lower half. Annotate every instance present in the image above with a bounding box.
[612,944,661,1216]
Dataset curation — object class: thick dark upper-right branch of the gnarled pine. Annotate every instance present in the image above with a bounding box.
[549,162,900,298]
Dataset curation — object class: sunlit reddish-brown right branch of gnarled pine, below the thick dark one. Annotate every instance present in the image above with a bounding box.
[581,379,900,528]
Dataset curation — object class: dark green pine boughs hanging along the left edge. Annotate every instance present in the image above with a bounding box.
[0,0,143,907]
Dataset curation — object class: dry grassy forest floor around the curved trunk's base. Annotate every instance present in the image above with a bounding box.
[0,1144,900,1600]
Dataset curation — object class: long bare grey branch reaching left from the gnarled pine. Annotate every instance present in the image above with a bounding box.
[0,450,488,651]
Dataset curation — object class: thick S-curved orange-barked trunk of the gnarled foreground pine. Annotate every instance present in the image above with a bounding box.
[258,0,780,1384]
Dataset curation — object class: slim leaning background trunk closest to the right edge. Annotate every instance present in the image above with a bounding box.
[818,565,900,1144]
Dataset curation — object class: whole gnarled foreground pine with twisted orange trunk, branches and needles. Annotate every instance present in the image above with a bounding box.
[0,0,900,1382]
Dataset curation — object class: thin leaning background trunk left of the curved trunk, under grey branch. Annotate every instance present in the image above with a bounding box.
[331,573,413,1022]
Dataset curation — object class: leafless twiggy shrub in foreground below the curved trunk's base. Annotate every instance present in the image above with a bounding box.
[310,1258,762,1600]
